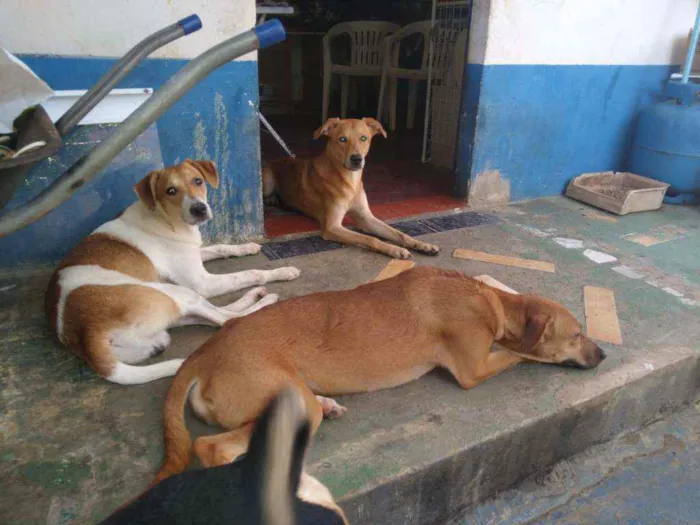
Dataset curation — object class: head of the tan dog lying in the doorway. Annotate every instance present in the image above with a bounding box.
[314,118,386,171]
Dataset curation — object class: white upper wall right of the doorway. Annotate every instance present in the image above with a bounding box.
[469,0,698,65]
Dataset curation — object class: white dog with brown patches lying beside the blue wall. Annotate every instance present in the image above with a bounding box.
[45,160,299,385]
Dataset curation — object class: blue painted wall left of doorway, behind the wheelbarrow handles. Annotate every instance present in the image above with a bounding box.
[0,55,263,266]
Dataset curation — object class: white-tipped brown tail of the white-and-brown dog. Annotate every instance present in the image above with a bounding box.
[81,330,184,385]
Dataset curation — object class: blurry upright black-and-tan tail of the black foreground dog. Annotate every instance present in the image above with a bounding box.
[245,388,311,525]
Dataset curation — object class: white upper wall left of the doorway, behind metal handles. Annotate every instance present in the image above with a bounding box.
[0,0,257,60]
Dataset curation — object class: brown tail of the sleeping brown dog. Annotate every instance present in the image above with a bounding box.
[152,366,197,485]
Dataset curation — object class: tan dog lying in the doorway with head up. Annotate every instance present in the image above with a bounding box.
[262,118,440,259]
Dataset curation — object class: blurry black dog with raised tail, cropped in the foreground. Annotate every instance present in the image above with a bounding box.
[102,389,347,525]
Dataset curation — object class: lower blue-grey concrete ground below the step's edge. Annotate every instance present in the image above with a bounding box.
[455,399,700,525]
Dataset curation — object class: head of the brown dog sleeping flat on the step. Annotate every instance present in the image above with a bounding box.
[499,295,605,368]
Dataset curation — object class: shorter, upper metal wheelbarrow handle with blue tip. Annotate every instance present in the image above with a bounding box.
[56,15,202,137]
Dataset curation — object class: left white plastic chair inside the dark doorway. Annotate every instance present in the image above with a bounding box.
[321,21,400,122]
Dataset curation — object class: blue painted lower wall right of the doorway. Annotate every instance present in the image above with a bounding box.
[458,64,678,200]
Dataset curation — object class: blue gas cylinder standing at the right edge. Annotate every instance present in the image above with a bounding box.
[629,83,700,203]
